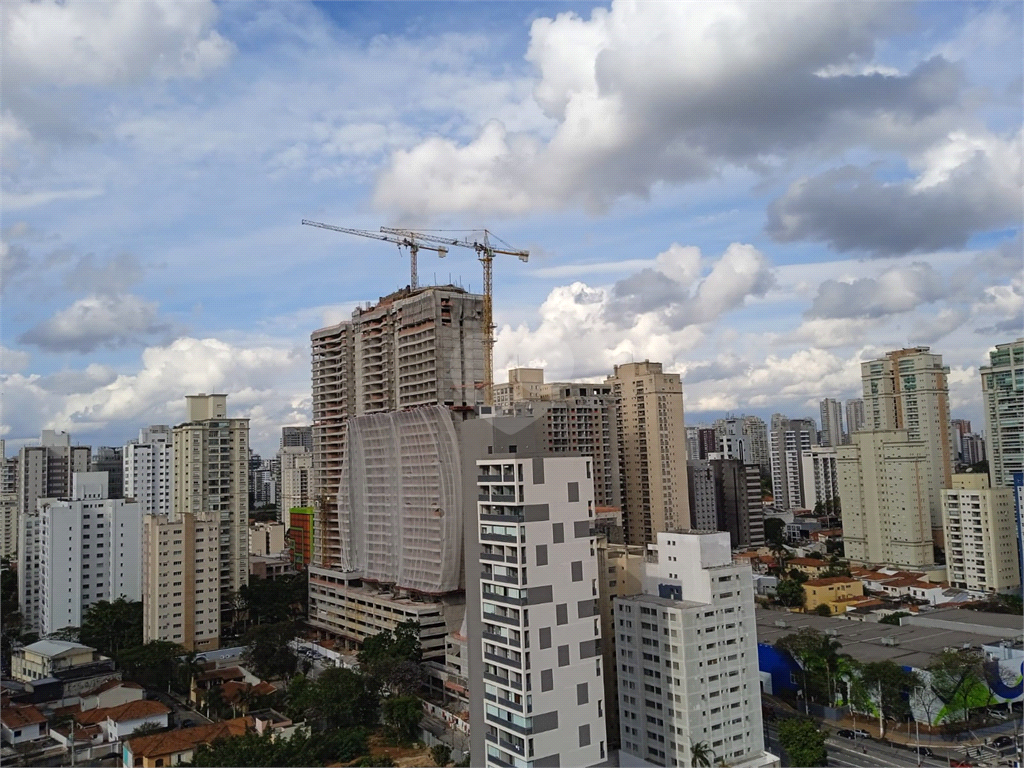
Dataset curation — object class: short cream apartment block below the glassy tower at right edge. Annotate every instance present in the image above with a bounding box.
[942,473,1021,593]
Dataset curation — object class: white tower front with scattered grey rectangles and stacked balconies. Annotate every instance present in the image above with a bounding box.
[472,455,607,768]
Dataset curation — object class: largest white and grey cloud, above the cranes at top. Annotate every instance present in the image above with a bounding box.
[375,1,963,216]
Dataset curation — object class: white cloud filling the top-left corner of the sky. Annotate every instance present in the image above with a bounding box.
[0,0,234,86]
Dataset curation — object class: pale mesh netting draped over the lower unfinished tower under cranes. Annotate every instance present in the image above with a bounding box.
[338,406,463,594]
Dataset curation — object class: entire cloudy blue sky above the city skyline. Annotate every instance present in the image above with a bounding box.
[0,0,1024,454]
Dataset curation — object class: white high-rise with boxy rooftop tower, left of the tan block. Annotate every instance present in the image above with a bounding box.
[18,472,142,635]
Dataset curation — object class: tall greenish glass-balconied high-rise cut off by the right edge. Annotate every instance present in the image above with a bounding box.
[981,338,1024,487]
